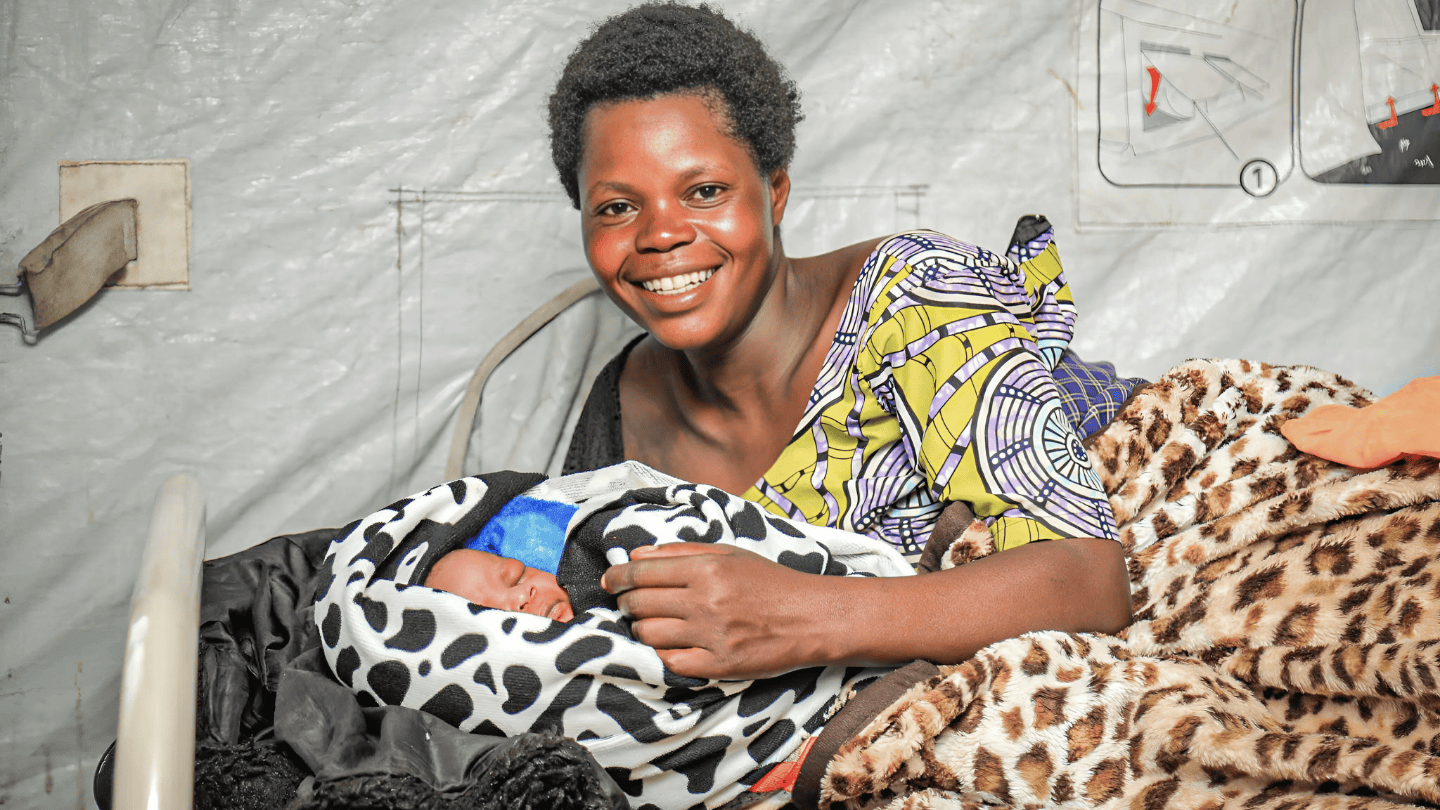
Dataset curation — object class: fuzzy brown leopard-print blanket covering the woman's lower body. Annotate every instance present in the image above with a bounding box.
[796,360,1440,810]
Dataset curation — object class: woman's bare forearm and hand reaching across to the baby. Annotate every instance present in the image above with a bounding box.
[603,538,1130,679]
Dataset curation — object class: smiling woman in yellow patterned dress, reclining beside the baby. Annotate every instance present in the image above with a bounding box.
[550,4,1129,679]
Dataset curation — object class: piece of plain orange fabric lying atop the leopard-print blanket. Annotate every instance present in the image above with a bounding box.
[1280,376,1440,470]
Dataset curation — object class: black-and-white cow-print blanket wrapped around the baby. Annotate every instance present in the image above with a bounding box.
[315,463,912,807]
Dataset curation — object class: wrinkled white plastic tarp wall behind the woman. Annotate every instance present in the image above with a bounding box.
[0,0,1440,809]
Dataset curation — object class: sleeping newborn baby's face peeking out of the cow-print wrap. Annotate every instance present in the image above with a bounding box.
[425,549,575,621]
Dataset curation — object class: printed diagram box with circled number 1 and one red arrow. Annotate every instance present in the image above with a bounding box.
[1099,0,1296,196]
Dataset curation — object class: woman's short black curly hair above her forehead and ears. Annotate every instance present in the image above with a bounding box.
[550,3,802,208]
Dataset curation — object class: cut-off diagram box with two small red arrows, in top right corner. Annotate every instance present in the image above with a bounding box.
[1299,0,1440,184]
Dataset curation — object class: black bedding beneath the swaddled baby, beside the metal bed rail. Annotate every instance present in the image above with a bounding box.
[101,529,629,810]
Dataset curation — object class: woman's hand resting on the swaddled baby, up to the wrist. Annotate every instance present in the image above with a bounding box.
[600,543,840,680]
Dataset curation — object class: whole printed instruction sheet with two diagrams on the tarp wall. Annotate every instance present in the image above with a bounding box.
[1076,0,1440,225]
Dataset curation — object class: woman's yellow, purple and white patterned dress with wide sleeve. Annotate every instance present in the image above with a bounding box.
[744,231,1116,553]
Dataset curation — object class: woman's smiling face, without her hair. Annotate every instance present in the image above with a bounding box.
[579,94,789,350]
